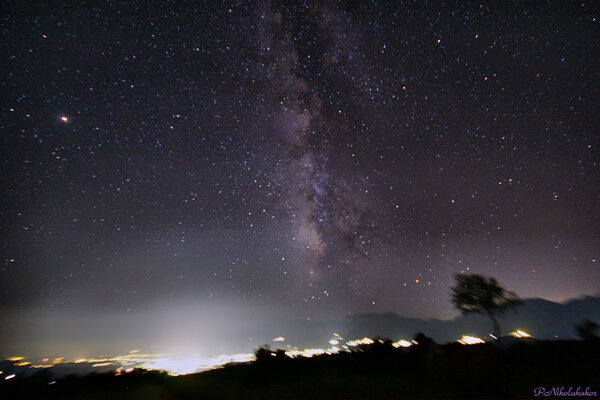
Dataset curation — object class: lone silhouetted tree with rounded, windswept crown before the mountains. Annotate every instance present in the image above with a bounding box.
[452,274,521,338]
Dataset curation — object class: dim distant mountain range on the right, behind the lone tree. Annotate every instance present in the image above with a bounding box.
[268,296,600,347]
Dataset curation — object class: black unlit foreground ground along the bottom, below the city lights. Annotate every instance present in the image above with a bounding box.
[0,341,600,400]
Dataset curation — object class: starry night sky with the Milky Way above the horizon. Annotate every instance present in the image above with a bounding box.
[0,1,600,352]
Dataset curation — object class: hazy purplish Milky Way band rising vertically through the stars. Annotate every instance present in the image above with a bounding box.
[260,7,375,279]
